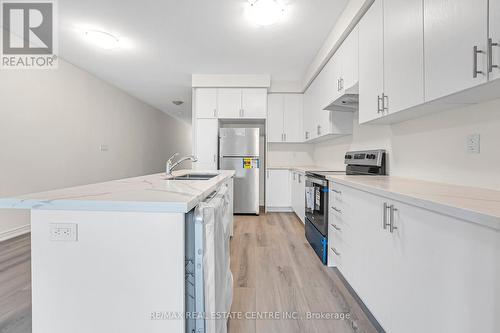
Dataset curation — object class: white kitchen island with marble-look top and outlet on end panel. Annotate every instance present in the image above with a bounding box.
[0,171,234,333]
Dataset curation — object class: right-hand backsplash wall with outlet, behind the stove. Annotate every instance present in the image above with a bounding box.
[314,100,500,189]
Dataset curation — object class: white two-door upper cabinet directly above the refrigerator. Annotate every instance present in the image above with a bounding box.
[218,88,267,119]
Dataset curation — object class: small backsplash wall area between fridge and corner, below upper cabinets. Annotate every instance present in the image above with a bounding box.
[267,143,314,167]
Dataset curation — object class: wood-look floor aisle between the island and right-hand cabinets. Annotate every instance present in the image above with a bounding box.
[229,213,377,333]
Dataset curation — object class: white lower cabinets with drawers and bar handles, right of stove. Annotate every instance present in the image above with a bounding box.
[329,183,500,333]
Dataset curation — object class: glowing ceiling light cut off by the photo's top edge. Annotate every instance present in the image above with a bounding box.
[246,0,286,26]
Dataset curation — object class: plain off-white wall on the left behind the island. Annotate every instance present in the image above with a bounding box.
[0,61,191,238]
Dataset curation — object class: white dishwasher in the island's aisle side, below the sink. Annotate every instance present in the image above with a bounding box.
[185,184,233,333]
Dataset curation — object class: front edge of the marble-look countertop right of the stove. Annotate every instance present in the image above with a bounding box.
[327,176,500,232]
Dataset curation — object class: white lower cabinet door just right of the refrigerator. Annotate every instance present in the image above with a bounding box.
[266,170,292,208]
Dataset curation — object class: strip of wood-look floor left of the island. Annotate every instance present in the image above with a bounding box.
[0,234,31,333]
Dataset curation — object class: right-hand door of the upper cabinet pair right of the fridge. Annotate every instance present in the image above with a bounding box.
[283,94,304,142]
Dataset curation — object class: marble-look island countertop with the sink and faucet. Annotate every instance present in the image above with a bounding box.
[0,170,234,213]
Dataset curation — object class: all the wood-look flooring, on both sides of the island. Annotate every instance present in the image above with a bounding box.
[0,213,377,333]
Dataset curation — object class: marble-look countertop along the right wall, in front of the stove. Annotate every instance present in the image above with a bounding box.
[327,175,500,230]
